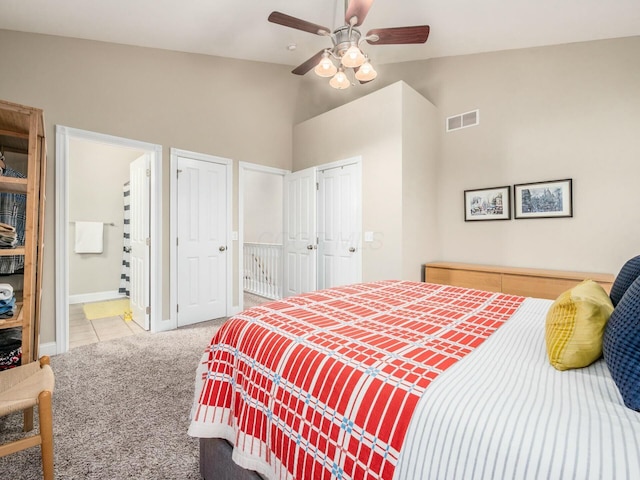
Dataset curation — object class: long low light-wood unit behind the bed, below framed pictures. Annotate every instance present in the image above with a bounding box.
[424,262,614,299]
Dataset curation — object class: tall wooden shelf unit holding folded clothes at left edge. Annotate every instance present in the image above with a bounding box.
[0,100,47,364]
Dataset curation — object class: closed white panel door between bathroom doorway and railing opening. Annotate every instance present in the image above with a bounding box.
[177,157,228,326]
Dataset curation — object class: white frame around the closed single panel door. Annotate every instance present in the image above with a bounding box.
[167,148,234,328]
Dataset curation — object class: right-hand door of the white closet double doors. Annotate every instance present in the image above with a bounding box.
[318,164,362,288]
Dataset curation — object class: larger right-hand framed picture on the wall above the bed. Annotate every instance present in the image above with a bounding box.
[513,178,573,219]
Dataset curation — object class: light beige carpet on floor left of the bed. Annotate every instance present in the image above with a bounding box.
[0,319,225,480]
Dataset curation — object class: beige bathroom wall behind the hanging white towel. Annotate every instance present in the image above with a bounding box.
[68,139,143,297]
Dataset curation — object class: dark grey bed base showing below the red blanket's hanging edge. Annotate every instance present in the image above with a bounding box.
[200,438,263,480]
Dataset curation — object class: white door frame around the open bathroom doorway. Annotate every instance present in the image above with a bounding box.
[55,125,162,354]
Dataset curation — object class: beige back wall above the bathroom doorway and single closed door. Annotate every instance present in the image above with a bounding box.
[0,30,299,342]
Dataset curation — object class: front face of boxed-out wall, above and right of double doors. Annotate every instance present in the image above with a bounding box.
[293,84,402,282]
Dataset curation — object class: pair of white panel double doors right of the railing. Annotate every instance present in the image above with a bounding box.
[284,161,362,296]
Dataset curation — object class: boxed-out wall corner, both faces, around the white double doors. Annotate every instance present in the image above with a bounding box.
[293,81,440,281]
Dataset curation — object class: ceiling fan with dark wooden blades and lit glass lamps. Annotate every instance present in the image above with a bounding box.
[268,0,429,89]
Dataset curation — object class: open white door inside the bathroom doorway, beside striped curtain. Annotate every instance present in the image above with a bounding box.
[129,154,151,330]
